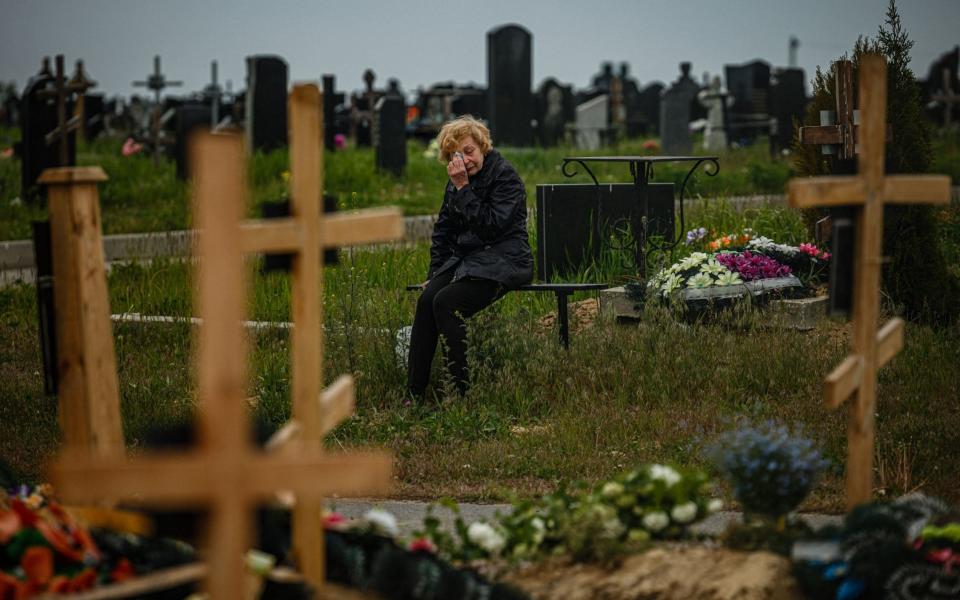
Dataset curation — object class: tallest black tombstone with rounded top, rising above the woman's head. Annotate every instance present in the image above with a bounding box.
[487,25,533,146]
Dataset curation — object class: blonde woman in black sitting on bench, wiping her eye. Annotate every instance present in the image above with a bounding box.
[407,116,533,397]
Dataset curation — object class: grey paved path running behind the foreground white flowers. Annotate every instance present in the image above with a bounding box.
[327,498,843,536]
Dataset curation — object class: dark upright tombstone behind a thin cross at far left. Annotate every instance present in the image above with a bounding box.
[17,59,76,202]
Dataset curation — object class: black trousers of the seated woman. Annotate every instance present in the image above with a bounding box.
[407,269,504,395]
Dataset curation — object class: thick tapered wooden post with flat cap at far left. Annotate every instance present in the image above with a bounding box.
[38,167,124,456]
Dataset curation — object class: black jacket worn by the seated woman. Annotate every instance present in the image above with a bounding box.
[427,150,533,289]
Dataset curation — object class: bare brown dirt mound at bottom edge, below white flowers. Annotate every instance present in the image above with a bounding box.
[505,546,803,600]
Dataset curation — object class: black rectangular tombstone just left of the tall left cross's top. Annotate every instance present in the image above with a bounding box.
[246,55,287,152]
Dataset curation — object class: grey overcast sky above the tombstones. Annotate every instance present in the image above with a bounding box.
[0,0,960,101]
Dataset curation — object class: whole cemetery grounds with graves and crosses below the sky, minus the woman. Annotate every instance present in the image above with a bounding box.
[0,2,960,600]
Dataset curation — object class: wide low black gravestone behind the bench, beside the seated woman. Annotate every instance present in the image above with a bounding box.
[537,183,675,281]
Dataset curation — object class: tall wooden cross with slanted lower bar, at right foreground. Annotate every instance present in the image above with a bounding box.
[788,54,950,508]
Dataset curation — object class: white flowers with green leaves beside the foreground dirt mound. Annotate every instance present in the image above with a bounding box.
[417,464,722,561]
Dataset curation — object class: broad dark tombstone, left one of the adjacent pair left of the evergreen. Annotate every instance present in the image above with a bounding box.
[724,60,770,144]
